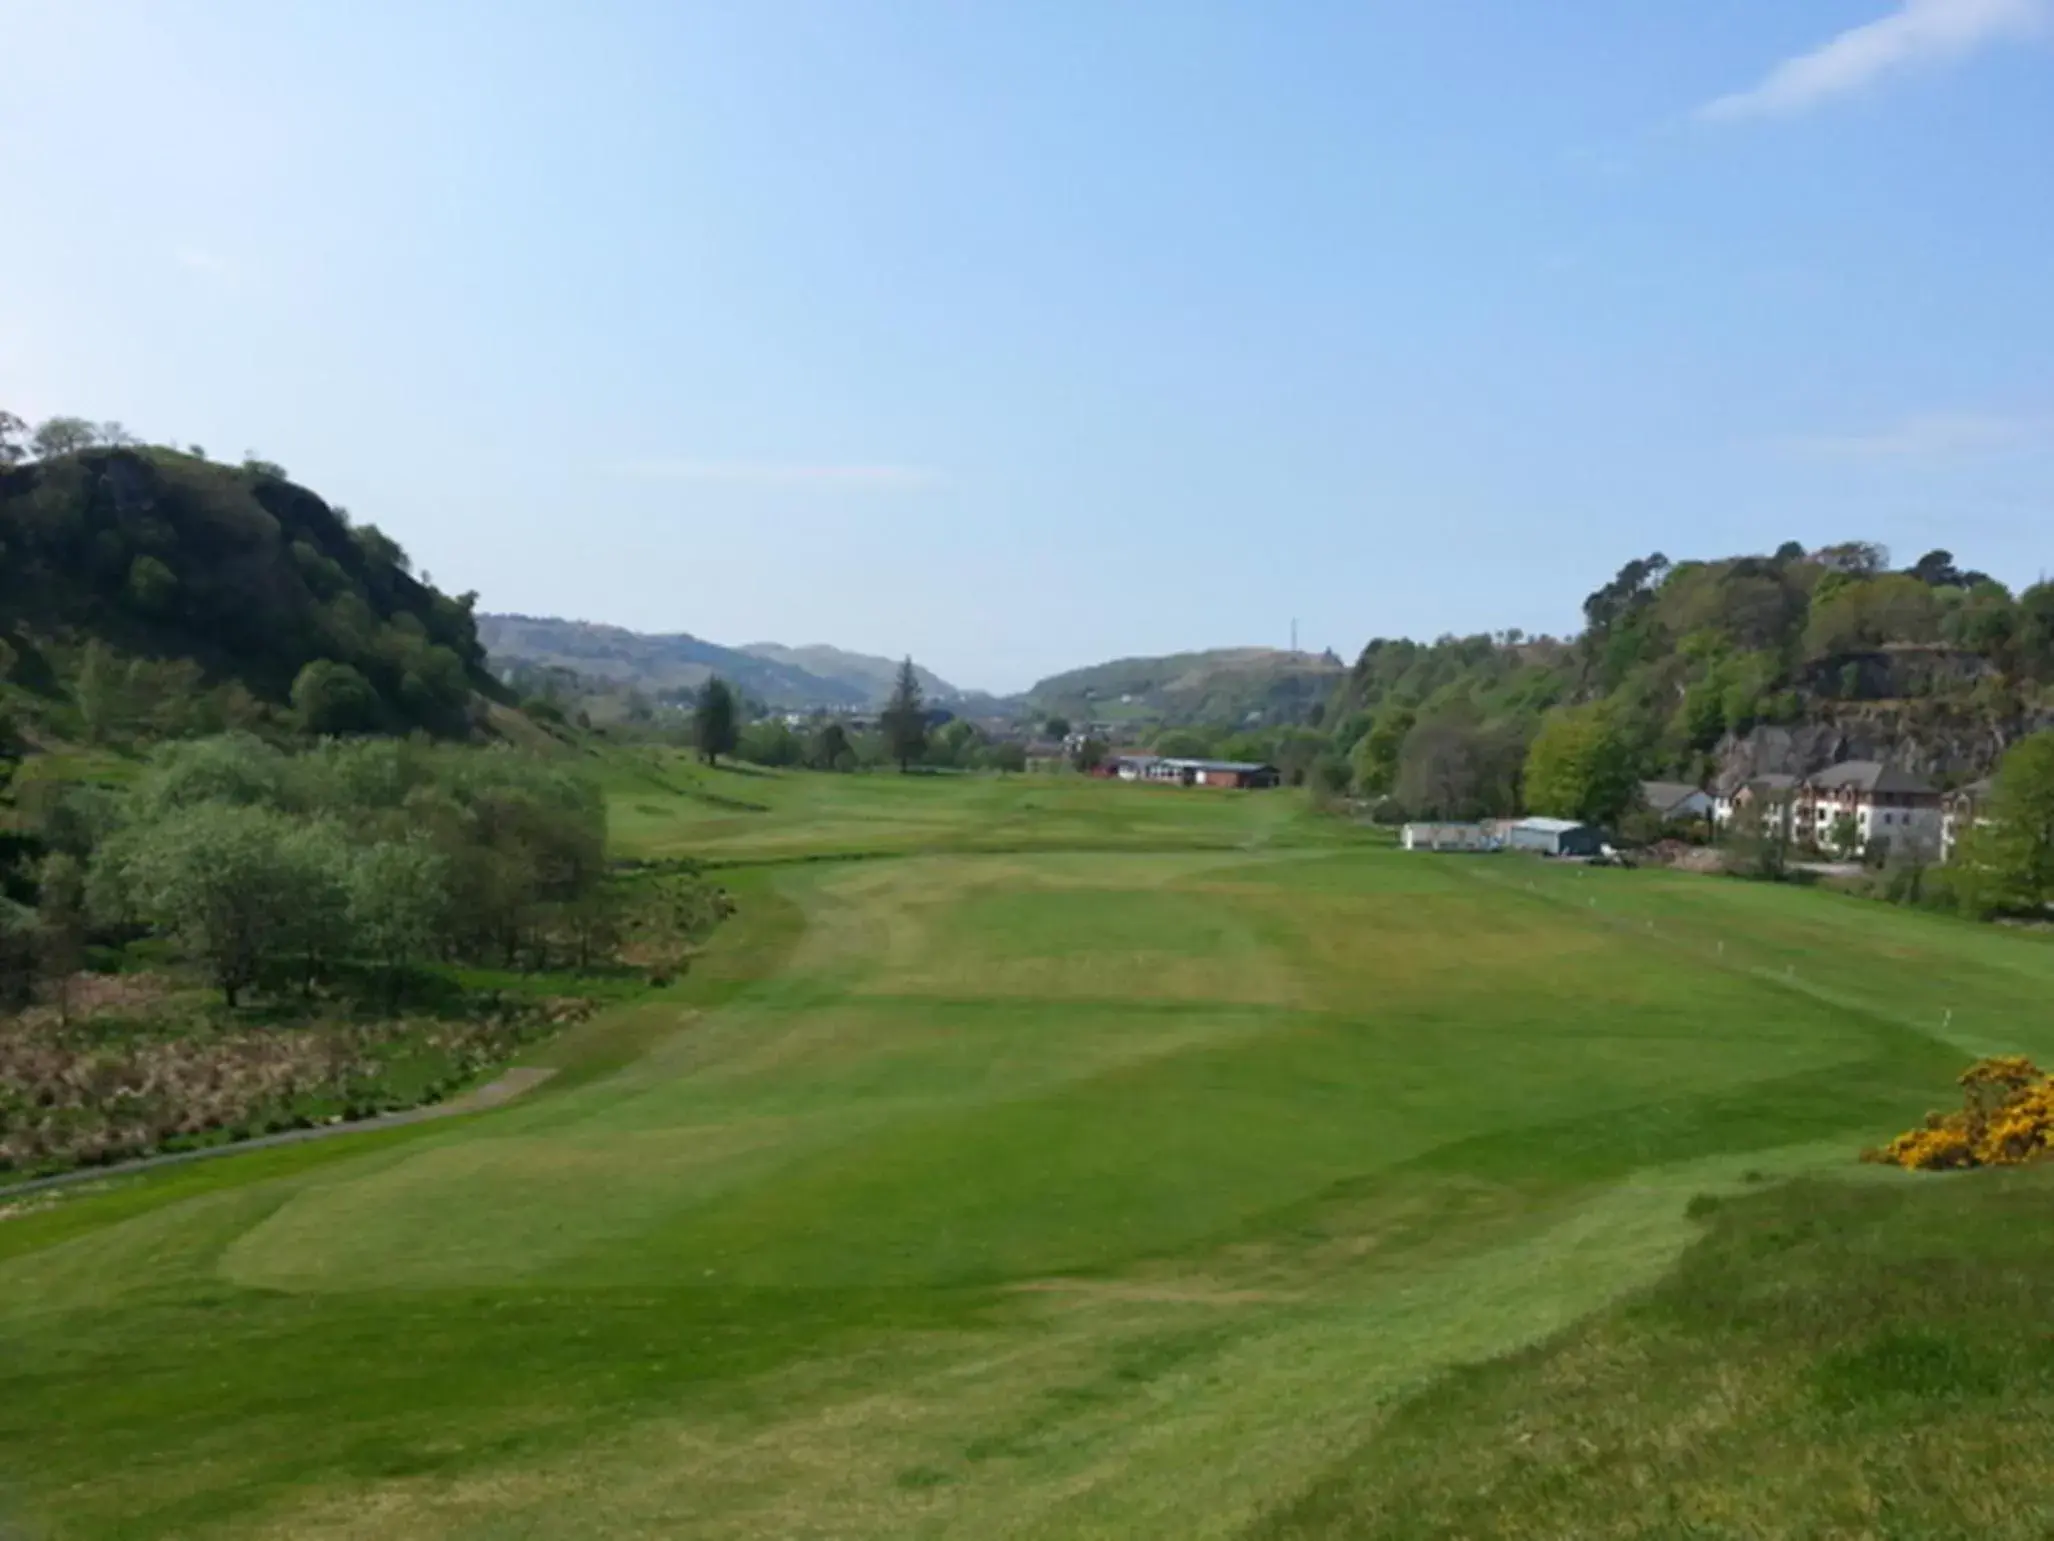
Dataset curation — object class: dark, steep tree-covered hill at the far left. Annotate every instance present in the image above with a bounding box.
[0,431,499,738]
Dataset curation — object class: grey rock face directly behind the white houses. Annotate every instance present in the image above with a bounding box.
[1713,701,2054,789]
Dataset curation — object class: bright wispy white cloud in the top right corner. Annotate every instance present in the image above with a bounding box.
[1699,0,2050,121]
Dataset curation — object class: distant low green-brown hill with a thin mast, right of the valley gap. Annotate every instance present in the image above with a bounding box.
[1025,647,1347,727]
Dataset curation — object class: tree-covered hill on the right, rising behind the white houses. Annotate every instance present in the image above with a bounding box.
[1323,542,2054,814]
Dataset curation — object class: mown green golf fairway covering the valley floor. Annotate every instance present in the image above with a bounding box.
[0,776,2054,1541]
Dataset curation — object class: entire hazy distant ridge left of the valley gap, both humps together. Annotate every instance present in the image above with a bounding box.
[479,614,967,711]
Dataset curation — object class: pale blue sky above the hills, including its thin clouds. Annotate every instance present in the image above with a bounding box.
[0,0,2054,688]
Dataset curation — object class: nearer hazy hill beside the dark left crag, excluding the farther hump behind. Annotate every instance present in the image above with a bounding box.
[479,614,871,711]
